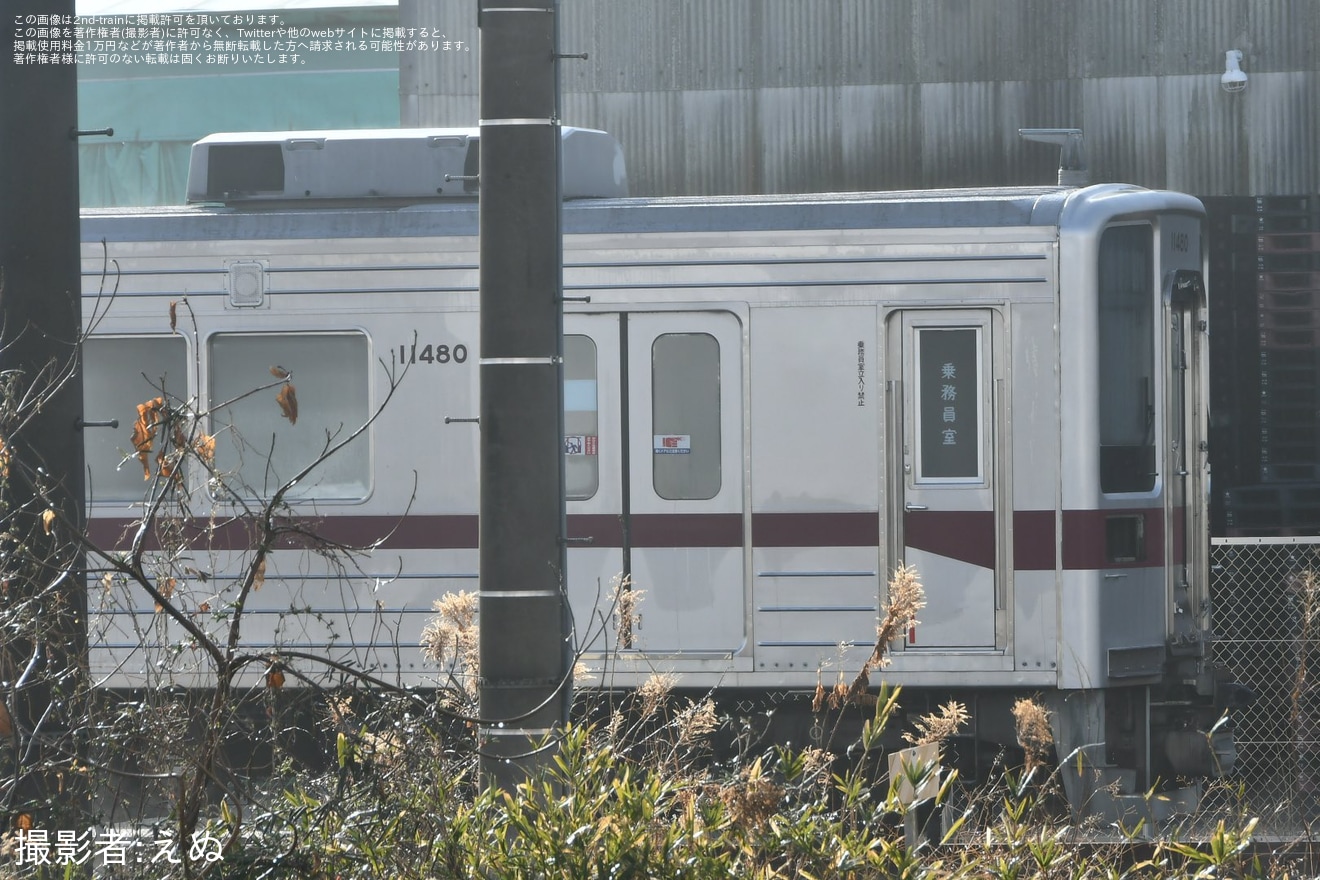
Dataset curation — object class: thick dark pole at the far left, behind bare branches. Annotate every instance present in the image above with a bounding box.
[0,0,87,809]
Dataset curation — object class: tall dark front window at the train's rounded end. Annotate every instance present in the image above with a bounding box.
[1098,224,1156,493]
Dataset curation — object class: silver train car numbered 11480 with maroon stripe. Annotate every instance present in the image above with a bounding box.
[82,129,1229,807]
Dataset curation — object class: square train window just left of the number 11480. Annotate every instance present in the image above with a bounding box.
[209,332,371,499]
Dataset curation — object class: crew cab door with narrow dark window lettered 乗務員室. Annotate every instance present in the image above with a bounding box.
[891,309,1005,649]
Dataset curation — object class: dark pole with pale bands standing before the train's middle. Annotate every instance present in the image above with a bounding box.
[478,0,573,789]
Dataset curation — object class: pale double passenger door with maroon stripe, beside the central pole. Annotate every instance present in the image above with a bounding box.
[565,311,746,653]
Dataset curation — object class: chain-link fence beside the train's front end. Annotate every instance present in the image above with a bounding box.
[1210,538,1320,817]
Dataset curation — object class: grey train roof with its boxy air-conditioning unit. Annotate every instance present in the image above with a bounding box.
[83,127,1199,241]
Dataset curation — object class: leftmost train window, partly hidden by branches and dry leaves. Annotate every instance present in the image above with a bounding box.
[82,336,189,501]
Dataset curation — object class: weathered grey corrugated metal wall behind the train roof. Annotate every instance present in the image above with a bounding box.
[400,0,1320,195]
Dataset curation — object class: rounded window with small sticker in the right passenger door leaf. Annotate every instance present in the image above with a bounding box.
[651,332,722,500]
